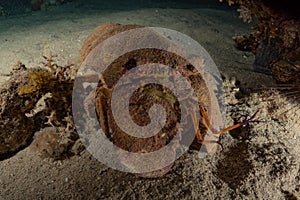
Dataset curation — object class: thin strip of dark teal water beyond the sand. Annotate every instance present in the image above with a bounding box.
[0,0,231,17]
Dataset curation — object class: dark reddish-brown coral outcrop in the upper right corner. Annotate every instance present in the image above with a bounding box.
[227,0,300,100]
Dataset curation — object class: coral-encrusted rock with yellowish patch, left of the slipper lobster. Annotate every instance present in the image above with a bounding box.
[0,55,78,159]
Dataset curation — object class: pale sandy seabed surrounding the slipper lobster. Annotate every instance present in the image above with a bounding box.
[0,0,300,199]
